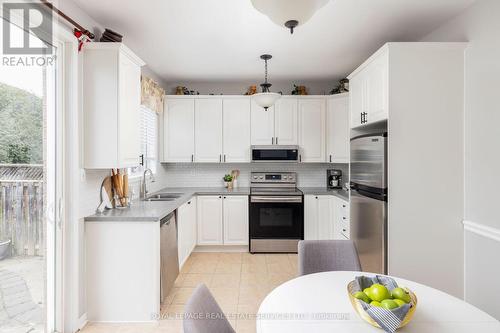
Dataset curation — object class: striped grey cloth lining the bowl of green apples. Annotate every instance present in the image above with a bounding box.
[354,275,411,333]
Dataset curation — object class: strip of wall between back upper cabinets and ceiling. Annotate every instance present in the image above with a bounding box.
[167,77,338,95]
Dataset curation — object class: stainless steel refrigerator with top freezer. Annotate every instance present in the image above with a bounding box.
[350,133,387,274]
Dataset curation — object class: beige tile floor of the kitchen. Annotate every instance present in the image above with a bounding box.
[82,252,297,333]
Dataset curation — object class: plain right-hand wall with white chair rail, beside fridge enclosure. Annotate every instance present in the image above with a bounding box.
[423,0,500,319]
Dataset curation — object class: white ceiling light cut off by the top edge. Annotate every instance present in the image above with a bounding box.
[252,0,330,34]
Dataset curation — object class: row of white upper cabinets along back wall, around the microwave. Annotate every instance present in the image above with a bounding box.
[162,94,349,163]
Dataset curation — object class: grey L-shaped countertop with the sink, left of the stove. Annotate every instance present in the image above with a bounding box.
[84,187,254,222]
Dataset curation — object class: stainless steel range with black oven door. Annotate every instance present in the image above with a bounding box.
[249,172,304,253]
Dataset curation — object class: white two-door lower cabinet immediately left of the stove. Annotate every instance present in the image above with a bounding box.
[197,195,248,245]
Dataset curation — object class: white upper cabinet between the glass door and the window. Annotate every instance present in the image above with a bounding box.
[82,43,144,169]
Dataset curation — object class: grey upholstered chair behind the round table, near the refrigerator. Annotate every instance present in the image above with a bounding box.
[299,240,361,275]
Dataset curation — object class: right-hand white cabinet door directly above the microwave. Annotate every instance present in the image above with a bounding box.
[274,97,299,145]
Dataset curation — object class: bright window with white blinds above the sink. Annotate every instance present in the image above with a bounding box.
[130,105,158,176]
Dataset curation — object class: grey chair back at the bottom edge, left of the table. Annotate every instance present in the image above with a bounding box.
[183,284,235,333]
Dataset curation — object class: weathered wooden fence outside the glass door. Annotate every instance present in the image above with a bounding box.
[0,181,44,256]
